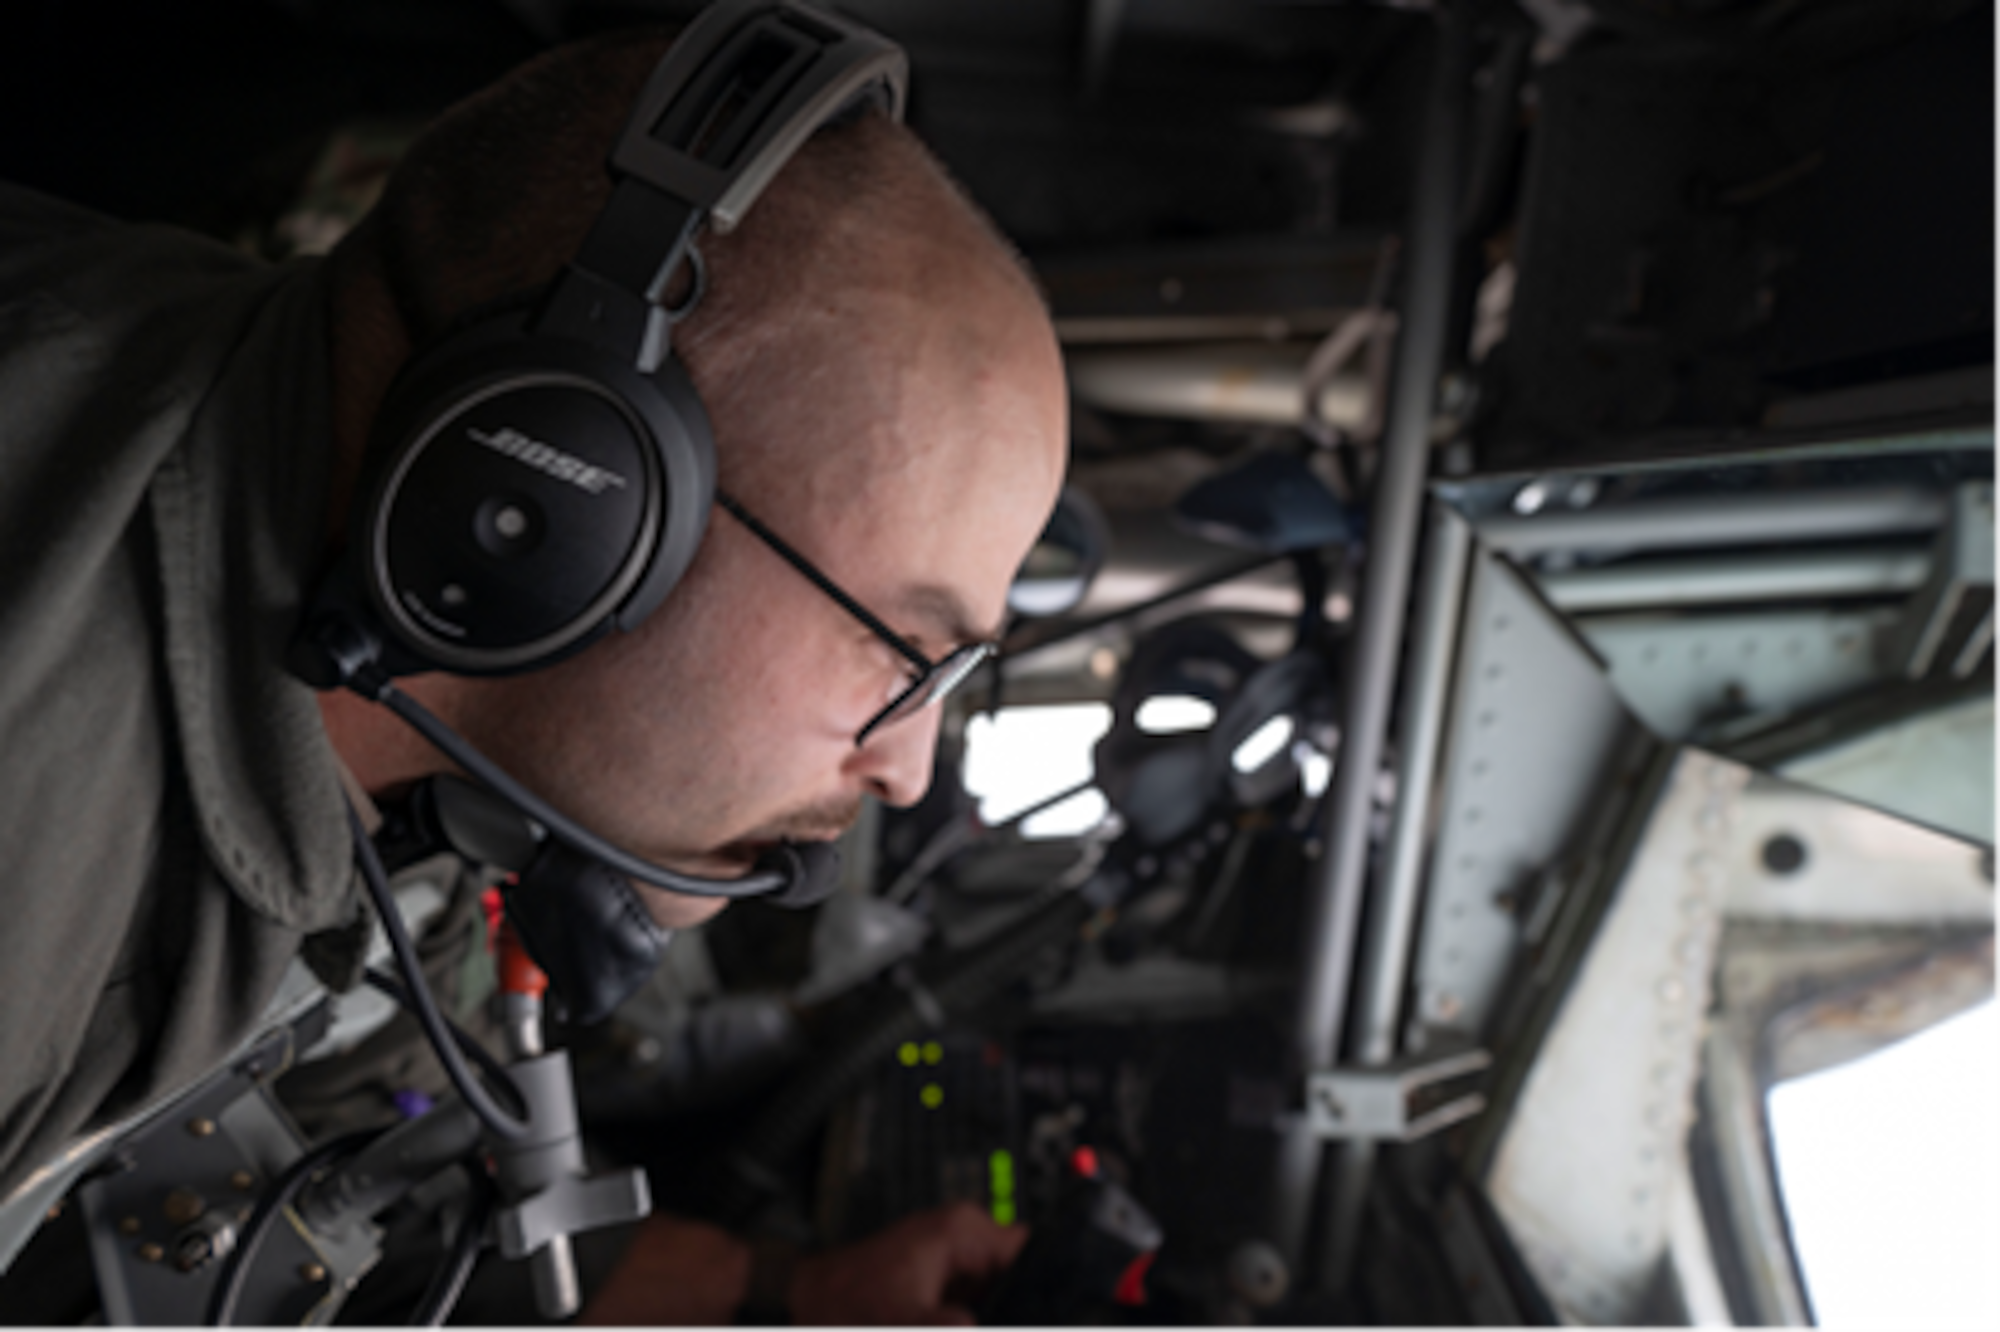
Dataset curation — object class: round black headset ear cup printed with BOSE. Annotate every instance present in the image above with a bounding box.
[348,318,714,674]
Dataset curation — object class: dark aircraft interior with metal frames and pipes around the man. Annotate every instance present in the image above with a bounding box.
[0,0,2000,1332]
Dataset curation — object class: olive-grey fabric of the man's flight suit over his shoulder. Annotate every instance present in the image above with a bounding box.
[0,186,358,1192]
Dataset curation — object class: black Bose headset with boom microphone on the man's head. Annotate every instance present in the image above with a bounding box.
[288,0,908,1008]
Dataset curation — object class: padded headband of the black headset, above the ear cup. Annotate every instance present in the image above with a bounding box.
[528,0,910,374]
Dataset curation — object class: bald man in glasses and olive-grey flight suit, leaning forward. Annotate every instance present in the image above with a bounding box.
[0,13,1064,1328]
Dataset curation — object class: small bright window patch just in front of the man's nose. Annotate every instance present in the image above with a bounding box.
[964,704,1112,838]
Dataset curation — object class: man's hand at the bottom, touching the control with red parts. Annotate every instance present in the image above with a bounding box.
[792,1202,1028,1332]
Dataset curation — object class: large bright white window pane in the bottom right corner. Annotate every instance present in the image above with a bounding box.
[1770,1000,2000,1332]
